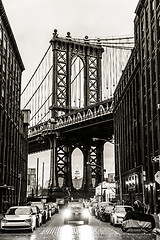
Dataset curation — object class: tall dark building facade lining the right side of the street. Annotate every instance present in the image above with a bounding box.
[114,0,160,213]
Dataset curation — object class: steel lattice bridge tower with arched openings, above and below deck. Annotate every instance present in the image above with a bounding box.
[48,30,104,198]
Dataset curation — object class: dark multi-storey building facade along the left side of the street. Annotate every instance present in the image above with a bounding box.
[0,1,28,213]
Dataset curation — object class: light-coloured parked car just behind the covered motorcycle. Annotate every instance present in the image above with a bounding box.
[110,205,134,226]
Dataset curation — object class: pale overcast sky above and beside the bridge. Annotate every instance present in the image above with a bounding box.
[2,0,138,187]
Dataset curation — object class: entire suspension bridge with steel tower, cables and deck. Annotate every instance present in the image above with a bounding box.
[21,30,134,197]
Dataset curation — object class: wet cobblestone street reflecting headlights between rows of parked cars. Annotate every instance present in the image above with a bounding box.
[0,210,160,240]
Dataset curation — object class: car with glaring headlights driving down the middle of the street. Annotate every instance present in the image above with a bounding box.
[64,202,89,224]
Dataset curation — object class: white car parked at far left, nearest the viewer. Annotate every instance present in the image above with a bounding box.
[1,206,36,232]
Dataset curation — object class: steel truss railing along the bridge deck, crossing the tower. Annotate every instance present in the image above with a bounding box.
[28,99,113,137]
